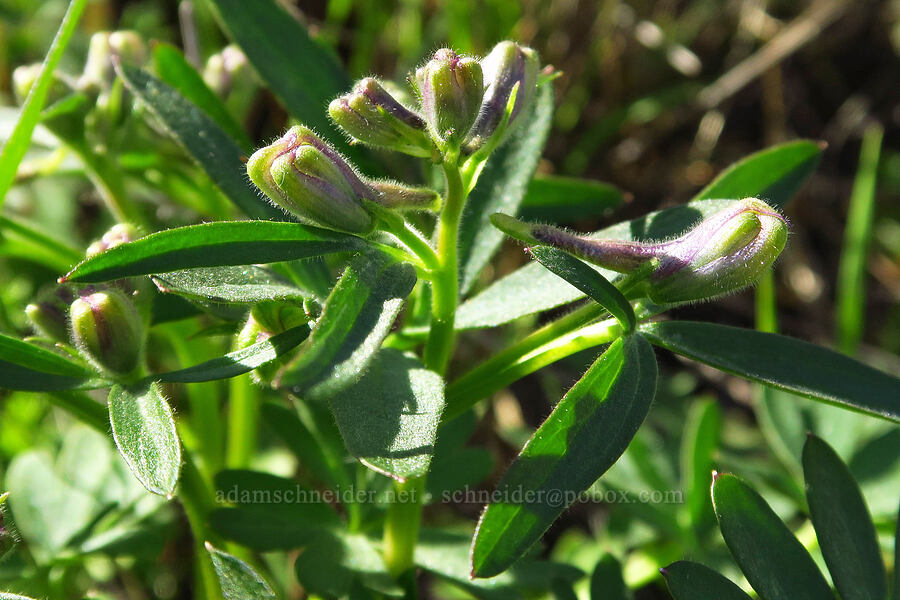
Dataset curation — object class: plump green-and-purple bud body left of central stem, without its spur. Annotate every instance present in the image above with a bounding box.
[247,125,375,234]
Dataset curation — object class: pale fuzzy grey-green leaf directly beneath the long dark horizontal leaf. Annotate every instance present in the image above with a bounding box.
[152,265,313,304]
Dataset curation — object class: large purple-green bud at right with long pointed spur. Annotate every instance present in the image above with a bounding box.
[491,198,788,304]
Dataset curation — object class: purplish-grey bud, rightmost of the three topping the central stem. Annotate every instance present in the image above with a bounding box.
[464,41,540,154]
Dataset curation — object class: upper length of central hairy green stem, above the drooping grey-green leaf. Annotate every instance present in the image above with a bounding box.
[423,162,466,374]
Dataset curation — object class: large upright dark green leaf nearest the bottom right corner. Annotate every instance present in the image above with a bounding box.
[803,435,887,600]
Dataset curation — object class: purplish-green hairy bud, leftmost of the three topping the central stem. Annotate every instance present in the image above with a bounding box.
[328,77,431,157]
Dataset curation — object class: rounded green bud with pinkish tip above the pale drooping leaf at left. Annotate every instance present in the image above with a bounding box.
[69,288,144,375]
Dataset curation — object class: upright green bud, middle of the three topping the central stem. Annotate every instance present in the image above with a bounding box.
[416,48,484,150]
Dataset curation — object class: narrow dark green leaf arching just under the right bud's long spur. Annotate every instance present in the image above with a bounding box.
[531,246,637,333]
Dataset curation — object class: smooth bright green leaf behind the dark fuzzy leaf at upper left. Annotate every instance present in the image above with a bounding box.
[153,43,251,150]
